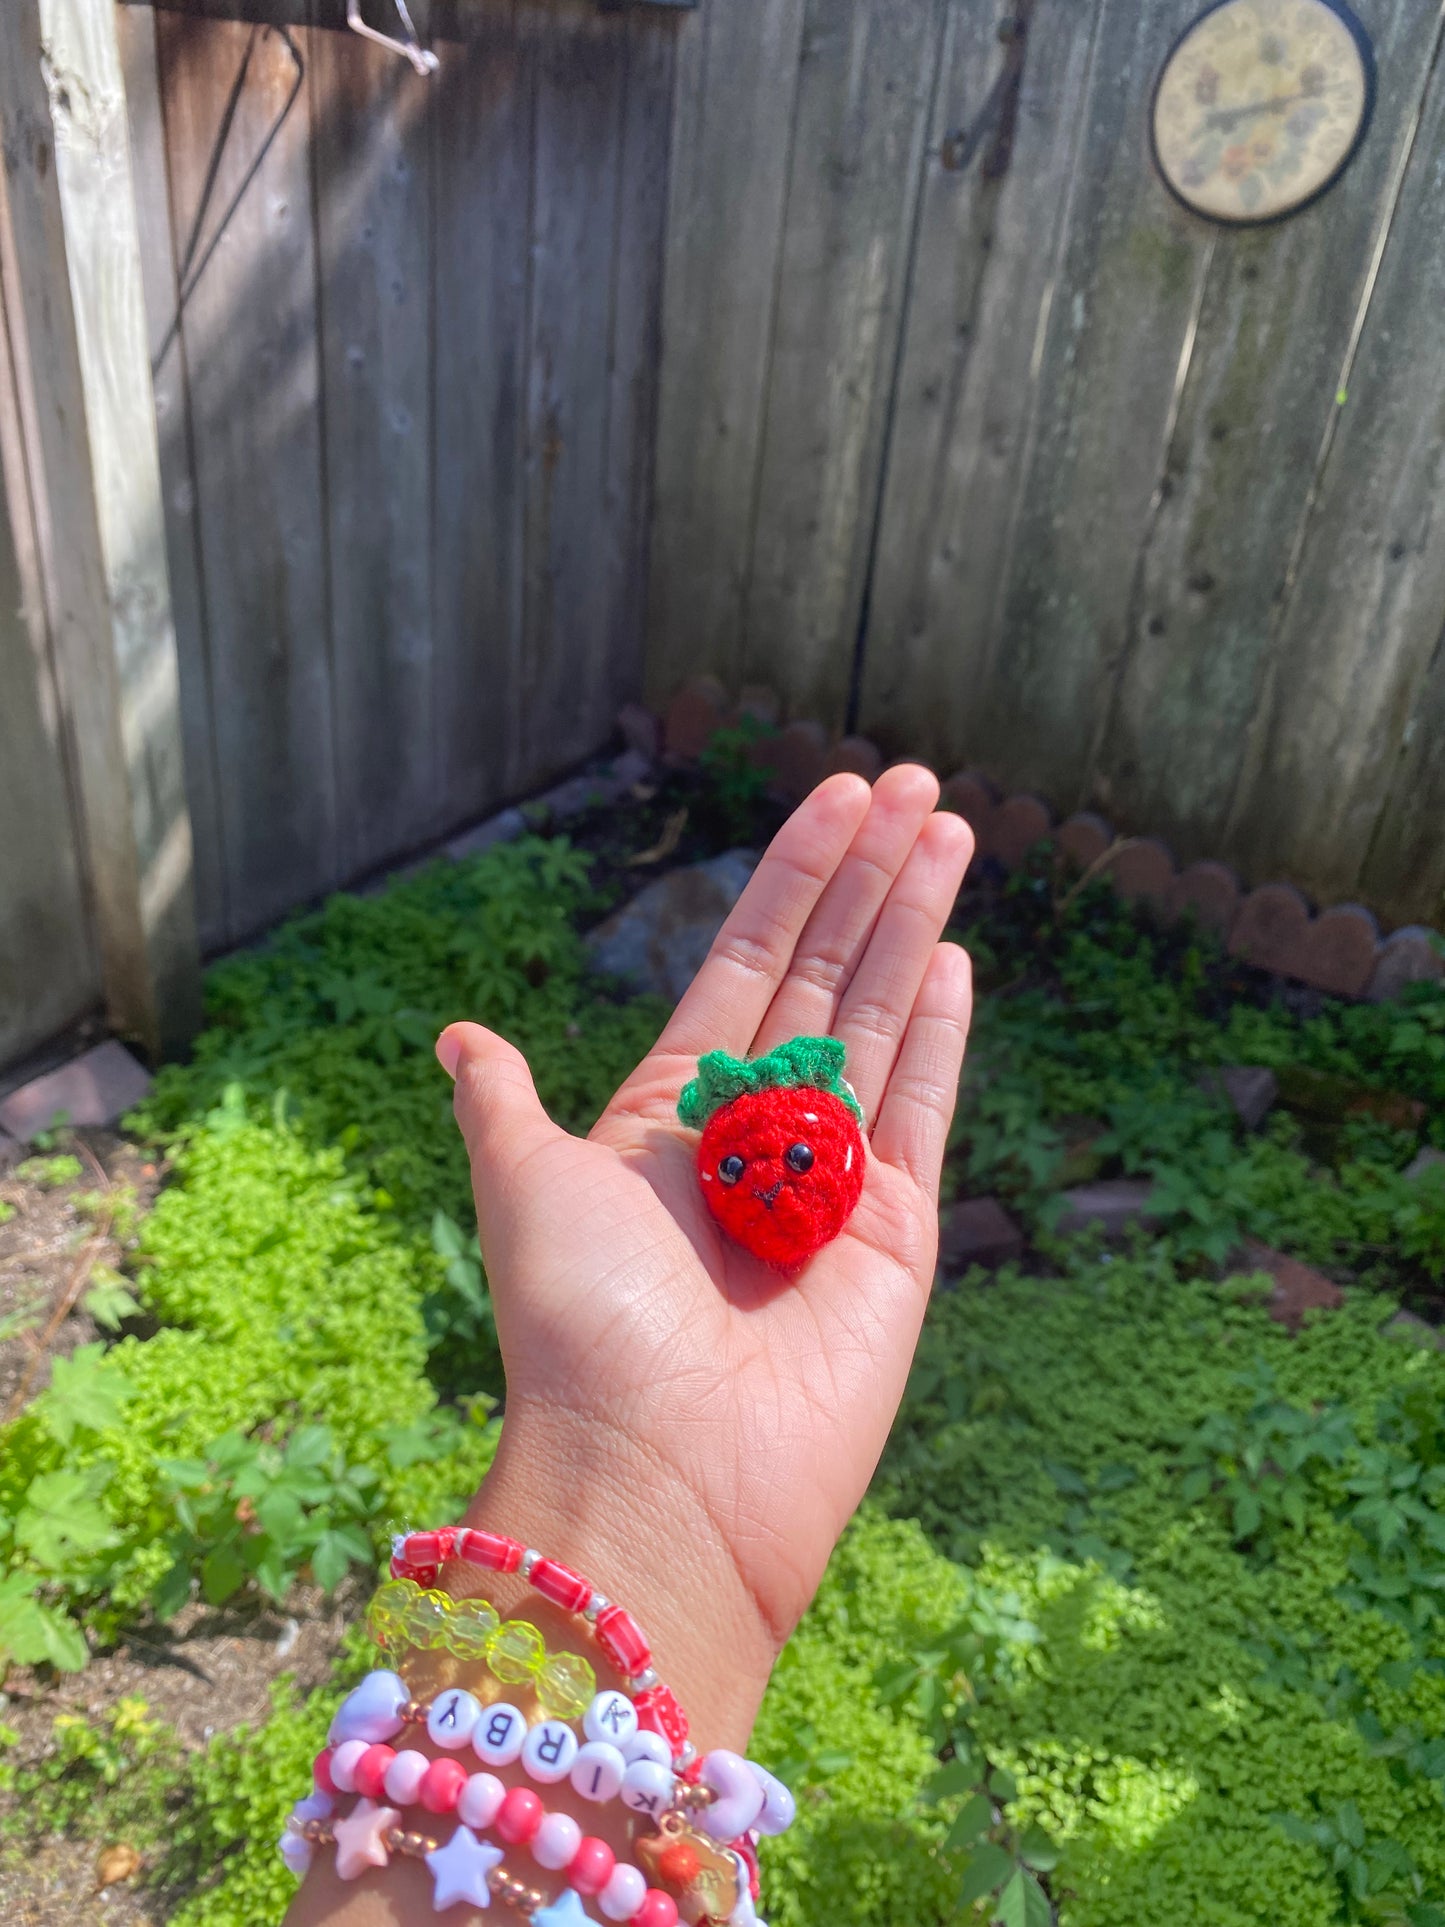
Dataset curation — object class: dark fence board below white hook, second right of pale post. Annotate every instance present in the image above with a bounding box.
[308,11,439,879]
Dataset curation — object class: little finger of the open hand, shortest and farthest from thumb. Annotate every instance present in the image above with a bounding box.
[873,944,973,1199]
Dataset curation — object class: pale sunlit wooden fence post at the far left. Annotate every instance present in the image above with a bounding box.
[0,0,200,1058]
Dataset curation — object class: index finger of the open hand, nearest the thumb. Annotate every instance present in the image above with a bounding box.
[655,777,869,1056]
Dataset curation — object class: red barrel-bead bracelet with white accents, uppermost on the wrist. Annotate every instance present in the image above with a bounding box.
[391,1526,696,1765]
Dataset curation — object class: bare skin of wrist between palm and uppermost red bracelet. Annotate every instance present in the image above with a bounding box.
[443,1399,780,1752]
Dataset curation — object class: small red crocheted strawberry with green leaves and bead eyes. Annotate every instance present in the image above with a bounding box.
[678,1037,863,1272]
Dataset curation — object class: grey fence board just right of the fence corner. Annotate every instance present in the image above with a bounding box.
[647,0,803,701]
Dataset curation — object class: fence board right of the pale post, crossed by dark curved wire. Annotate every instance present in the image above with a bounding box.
[156,13,339,937]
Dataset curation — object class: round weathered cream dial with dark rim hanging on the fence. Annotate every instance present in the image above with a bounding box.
[1154,0,1374,222]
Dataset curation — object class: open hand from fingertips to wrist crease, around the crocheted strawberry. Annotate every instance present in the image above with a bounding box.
[437,765,971,1703]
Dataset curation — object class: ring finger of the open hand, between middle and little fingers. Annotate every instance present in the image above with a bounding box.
[834,813,973,1118]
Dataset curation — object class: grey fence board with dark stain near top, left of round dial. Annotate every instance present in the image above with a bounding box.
[859,0,1098,769]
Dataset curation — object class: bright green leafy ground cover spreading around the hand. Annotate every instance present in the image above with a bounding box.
[0,782,1445,1927]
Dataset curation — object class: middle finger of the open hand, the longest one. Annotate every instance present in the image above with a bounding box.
[751,763,938,1075]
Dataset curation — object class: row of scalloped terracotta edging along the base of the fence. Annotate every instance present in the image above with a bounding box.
[658,676,1445,1002]
